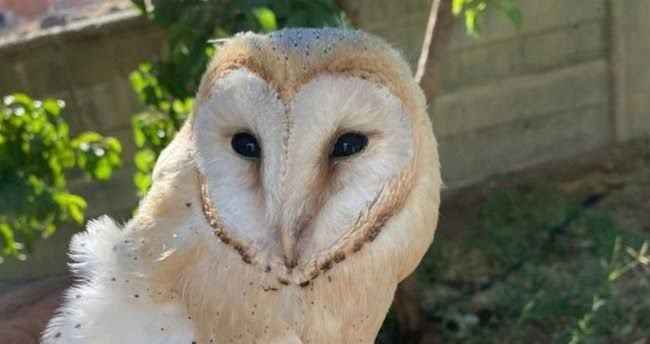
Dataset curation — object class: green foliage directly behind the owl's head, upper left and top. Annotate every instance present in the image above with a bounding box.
[131,0,343,196]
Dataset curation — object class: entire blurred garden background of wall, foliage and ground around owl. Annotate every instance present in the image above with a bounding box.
[0,0,650,344]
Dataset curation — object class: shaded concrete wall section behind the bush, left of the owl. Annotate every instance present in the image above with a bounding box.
[0,11,164,286]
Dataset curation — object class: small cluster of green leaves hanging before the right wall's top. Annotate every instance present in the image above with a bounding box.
[451,0,522,36]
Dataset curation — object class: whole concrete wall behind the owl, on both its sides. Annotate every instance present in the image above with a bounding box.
[0,0,650,280]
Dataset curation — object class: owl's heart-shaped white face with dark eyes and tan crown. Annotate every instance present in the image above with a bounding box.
[187,29,430,284]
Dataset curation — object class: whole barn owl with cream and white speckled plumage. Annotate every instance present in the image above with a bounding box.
[43,29,441,344]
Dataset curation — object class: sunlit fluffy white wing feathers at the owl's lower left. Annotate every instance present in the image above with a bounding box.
[42,217,194,344]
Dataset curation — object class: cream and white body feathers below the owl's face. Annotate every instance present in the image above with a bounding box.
[44,212,393,344]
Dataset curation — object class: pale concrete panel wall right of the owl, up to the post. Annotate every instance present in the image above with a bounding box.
[350,0,624,188]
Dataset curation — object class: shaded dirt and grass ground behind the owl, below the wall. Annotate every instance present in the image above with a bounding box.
[0,139,650,344]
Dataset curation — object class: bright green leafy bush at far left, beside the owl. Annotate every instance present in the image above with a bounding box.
[0,94,122,259]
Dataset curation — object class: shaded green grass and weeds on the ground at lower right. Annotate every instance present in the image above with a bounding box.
[379,185,650,344]
